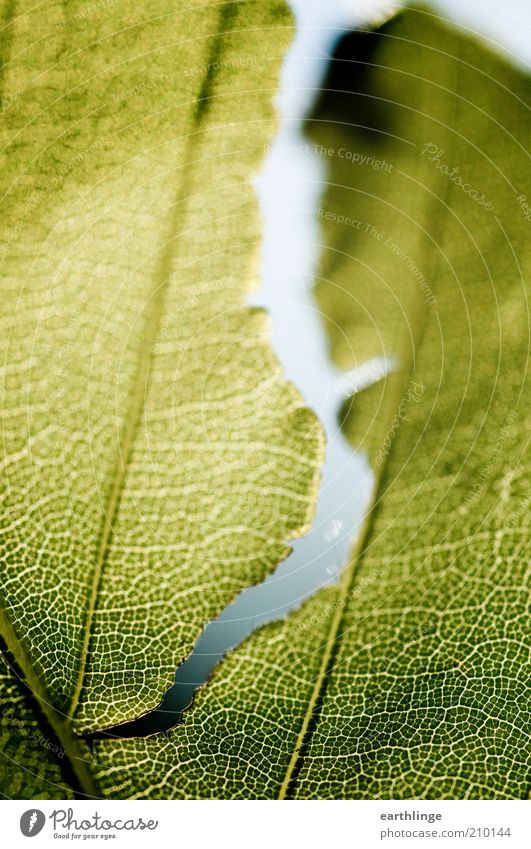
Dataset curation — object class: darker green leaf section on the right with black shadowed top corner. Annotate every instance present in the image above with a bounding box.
[96,10,531,799]
